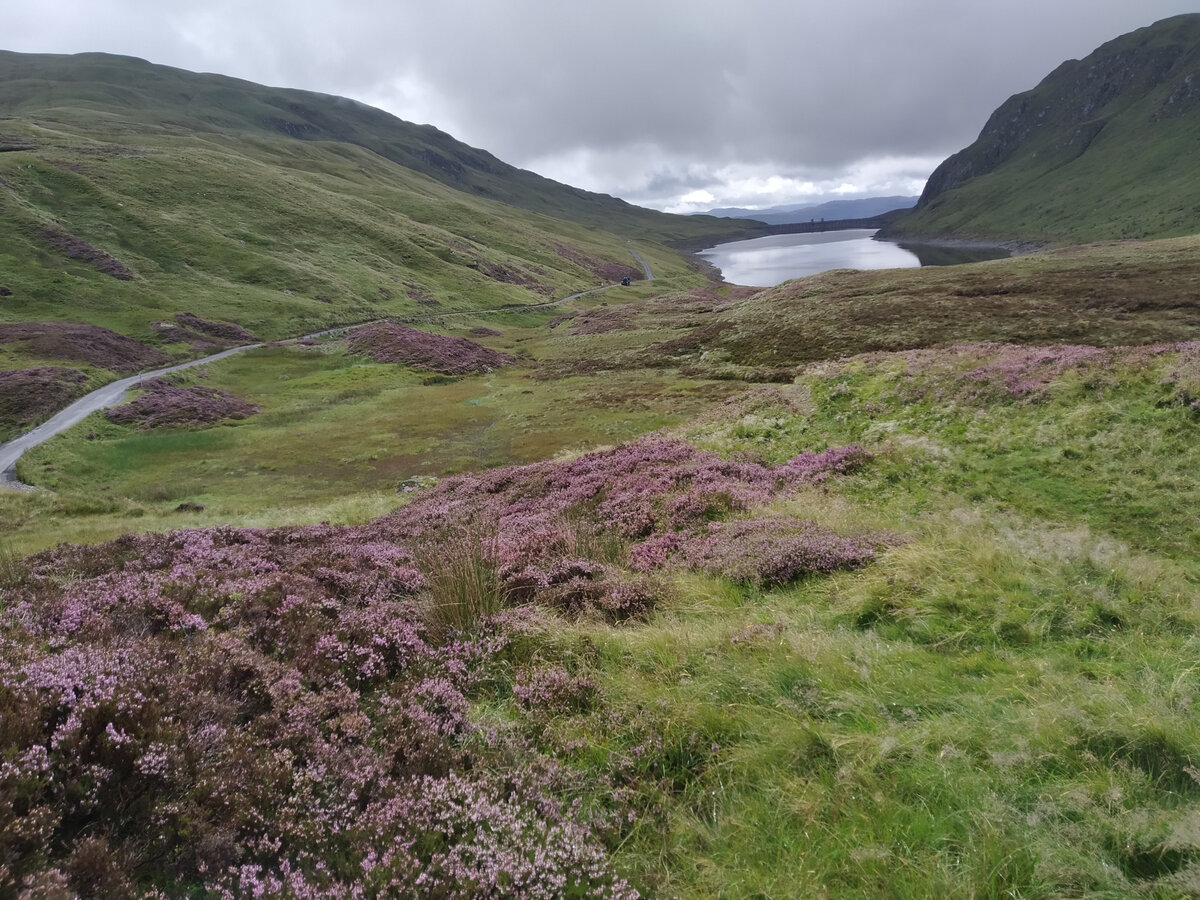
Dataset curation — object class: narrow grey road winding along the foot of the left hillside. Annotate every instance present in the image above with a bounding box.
[0,247,654,491]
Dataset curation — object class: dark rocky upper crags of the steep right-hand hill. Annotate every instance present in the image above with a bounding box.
[899,14,1200,240]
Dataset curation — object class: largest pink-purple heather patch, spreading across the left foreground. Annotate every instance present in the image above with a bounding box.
[0,439,883,898]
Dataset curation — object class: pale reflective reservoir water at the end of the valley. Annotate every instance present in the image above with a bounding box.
[698,228,1009,288]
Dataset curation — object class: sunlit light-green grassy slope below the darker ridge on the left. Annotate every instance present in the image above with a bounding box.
[0,117,684,340]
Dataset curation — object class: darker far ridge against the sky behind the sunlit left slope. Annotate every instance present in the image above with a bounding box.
[0,50,753,240]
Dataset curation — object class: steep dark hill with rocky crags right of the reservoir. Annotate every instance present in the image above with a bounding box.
[887,14,1200,242]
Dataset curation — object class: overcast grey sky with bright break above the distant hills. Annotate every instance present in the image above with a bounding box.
[9,0,1200,212]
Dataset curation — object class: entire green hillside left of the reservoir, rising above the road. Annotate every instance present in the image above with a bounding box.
[0,53,754,438]
